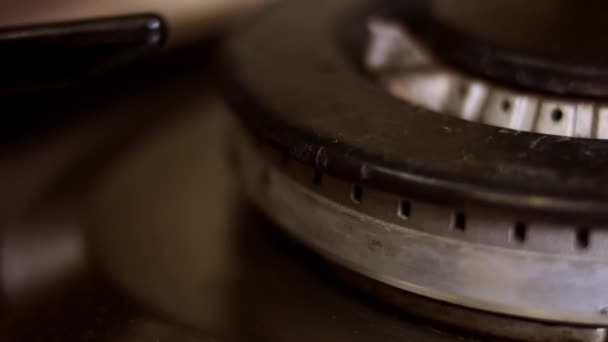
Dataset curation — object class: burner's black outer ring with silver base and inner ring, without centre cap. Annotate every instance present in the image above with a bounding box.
[227,0,608,341]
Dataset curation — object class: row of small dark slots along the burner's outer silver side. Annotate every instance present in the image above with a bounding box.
[313,170,590,249]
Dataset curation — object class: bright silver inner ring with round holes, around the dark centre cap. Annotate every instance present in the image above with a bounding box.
[367,20,608,139]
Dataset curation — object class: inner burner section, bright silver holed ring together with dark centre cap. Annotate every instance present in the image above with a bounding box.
[367,0,608,139]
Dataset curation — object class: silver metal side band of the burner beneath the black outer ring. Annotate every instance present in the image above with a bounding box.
[239,135,608,341]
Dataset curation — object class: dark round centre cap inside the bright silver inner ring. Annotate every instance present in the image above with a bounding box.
[406,0,608,96]
